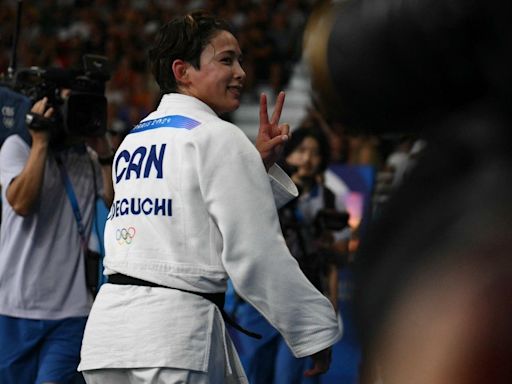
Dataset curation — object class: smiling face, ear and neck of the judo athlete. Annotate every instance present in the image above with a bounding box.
[179,30,245,115]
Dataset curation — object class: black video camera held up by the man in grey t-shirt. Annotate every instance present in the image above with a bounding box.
[4,55,110,139]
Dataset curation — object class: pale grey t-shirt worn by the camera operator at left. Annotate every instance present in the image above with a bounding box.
[0,135,103,319]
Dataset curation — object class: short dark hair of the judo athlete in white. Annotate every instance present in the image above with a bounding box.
[149,10,233,93]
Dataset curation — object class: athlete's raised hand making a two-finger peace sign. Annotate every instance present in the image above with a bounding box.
[256,91,290,171]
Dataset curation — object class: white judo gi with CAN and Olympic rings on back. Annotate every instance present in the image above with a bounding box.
[79,94,341,383]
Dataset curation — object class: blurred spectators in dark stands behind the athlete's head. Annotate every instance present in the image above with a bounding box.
[0,0,314,134]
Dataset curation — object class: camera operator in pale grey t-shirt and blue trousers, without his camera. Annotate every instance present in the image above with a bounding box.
[0,97,113,384]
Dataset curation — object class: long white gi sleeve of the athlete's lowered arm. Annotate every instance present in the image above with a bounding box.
[198,125,341,357]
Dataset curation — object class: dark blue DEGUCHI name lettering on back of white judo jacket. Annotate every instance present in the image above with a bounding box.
[107,197,172,220]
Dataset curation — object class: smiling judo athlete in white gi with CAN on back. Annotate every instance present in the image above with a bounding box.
[79,11,340,384]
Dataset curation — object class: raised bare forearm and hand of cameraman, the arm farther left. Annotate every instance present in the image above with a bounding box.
[6,97,53,216]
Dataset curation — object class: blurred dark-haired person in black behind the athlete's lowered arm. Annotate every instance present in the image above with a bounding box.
[279,127,350,308]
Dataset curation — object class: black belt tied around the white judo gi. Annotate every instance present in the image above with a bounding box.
[108,273,261,339]
